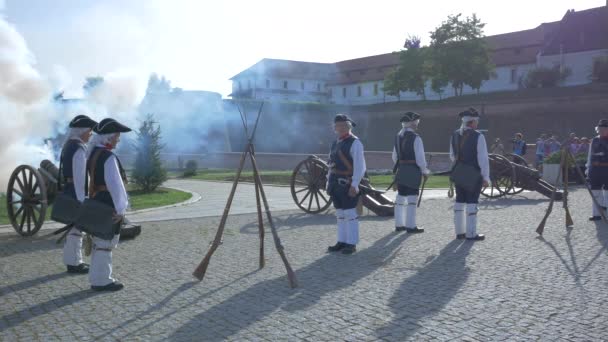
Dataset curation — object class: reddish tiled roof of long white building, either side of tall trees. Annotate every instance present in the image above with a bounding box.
[231,7,608,85]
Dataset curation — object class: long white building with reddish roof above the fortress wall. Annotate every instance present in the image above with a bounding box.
[230,6,608,105]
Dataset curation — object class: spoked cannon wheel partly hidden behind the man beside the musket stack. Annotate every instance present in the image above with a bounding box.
[291,157,331,214]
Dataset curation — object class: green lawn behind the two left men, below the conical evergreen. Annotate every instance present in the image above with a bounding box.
[0,186,192,224]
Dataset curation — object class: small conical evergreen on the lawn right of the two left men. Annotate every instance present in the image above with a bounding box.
[132,114,167,192]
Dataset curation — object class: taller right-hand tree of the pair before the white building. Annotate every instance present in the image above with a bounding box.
[428,14,494,96]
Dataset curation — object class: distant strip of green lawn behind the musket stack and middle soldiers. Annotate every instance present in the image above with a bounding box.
[169,169,449,190]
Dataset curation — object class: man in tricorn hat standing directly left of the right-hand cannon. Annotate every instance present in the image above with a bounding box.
[450,108,490,240]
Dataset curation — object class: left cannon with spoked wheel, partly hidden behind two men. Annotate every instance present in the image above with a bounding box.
[6,159,141,238]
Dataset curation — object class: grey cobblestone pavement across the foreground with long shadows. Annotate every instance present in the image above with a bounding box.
[0,190,608,341]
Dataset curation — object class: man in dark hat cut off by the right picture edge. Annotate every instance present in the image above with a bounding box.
[586,119,608,221]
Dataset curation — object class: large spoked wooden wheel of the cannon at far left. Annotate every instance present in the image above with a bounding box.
[6,165,48,236]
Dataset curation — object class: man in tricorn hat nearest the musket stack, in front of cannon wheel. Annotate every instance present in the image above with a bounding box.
[327,114,365,254]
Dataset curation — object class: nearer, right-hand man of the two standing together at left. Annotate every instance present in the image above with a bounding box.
[88,118,131,291]
